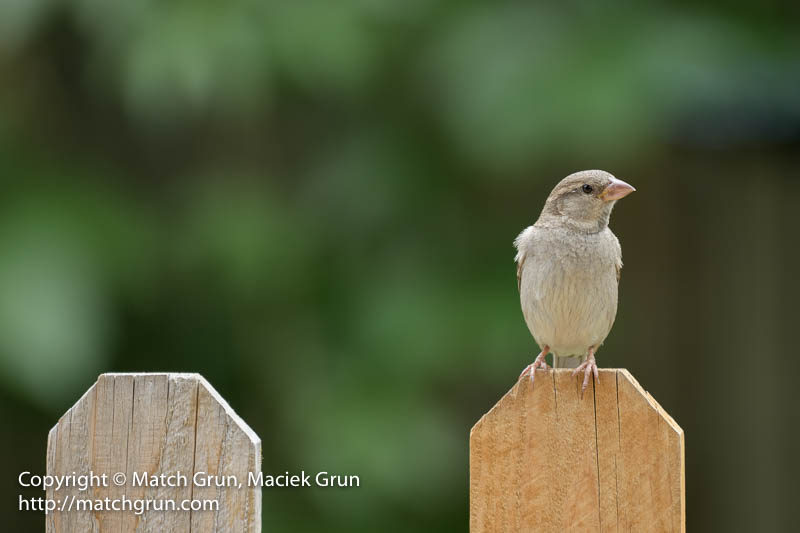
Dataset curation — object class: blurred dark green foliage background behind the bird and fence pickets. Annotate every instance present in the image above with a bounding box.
[0,0,800,532]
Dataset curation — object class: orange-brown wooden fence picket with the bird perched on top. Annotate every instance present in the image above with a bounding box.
[470,369,686,533]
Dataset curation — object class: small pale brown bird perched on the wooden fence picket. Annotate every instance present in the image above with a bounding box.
[514,170,636,397]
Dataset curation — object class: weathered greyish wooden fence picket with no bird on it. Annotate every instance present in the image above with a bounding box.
[46,373,261,533]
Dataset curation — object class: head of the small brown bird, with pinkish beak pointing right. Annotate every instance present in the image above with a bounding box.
[542,170,636,233]
